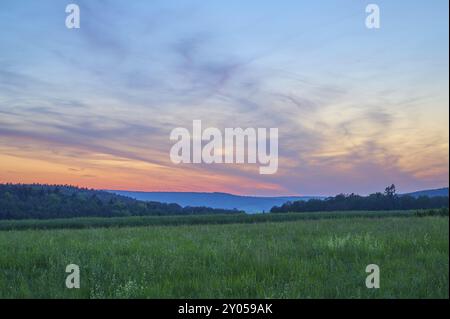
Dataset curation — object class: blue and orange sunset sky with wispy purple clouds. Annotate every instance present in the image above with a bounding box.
[0,0,449,196]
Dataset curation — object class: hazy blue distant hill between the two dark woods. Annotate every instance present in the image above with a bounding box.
[109,191,324,214]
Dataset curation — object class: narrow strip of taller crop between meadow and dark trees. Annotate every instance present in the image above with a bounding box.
[0,208,448,231]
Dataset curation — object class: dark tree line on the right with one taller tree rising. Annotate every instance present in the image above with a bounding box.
[271,185,449,213]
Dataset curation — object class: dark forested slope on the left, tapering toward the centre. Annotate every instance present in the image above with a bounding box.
[0,184,242,220]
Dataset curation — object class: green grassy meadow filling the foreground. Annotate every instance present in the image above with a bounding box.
[0,217,449,298]
